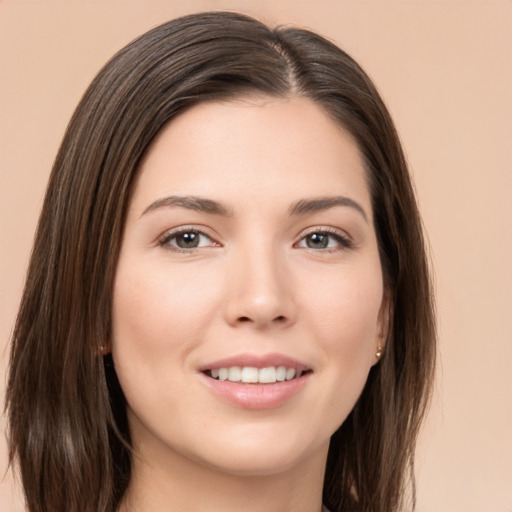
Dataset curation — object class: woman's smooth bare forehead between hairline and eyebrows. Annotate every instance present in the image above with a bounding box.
[133,97,371,215]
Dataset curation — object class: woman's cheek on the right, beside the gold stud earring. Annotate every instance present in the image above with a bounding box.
[300,266,383,420]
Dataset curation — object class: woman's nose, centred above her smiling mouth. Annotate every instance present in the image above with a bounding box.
[226,243,296,329]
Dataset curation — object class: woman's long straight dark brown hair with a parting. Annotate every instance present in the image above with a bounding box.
[7,12,435,512]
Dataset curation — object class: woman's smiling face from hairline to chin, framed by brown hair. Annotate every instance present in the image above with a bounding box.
[112,98,387,475]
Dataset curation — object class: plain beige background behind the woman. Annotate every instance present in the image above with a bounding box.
[0,0,512,512]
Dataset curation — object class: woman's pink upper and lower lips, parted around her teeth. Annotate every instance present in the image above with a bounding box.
[198,354,311,410]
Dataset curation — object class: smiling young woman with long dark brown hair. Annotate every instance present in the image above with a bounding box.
[7,13,435,512]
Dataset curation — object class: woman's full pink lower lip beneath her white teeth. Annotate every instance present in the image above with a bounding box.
[201,373,311,410]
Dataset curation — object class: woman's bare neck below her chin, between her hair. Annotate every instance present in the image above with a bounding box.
[120,436,328,512]
